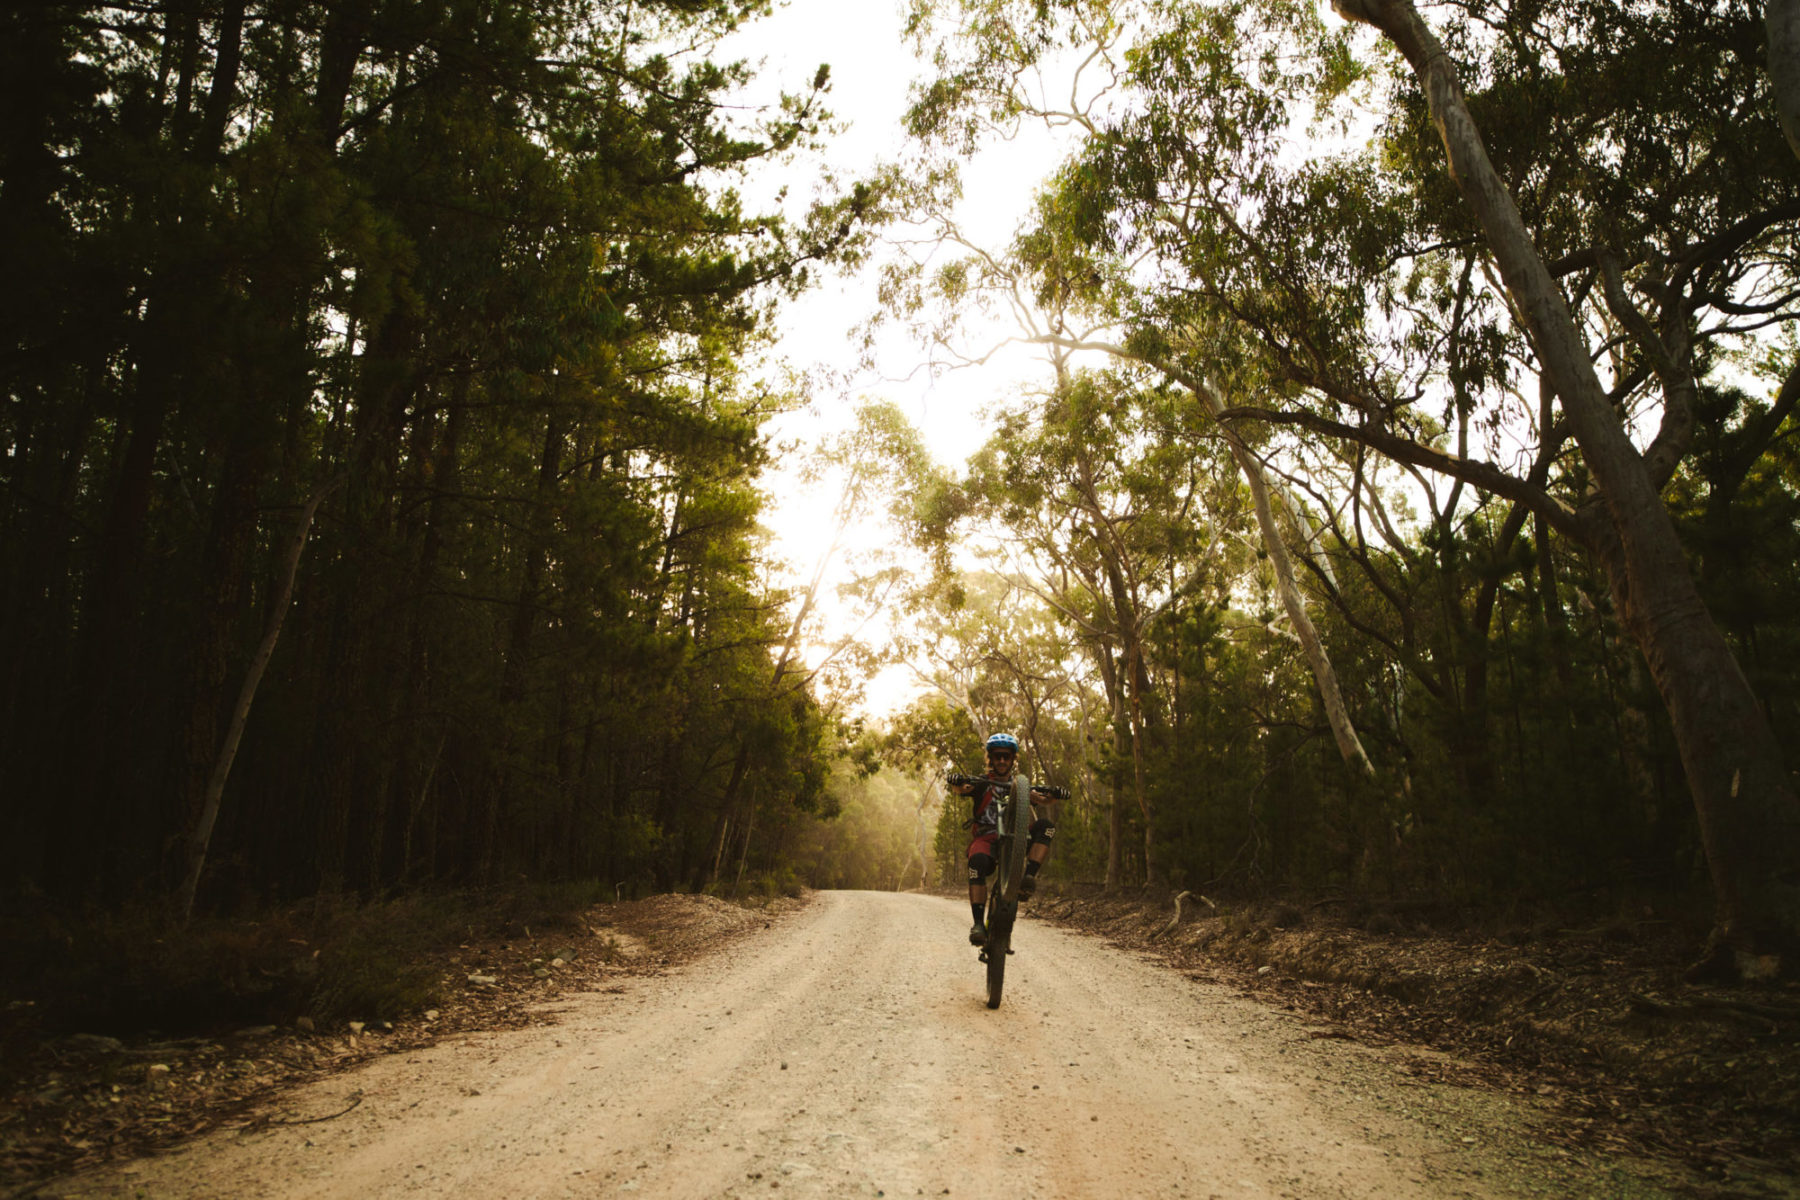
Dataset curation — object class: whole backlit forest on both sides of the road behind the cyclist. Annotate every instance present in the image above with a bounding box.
[0,0,1800,985]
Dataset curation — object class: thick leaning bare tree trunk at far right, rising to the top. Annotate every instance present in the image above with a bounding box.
[1334,0,1800,975]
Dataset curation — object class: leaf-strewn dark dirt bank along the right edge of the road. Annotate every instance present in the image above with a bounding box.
[1031,883,1800,1196]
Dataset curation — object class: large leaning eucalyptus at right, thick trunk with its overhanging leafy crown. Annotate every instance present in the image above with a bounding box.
[914,0,1800,972]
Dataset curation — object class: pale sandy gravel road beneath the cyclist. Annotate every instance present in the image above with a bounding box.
[41,892,1677,1200]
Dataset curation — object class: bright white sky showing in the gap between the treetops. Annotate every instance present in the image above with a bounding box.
[724,0,1080,716]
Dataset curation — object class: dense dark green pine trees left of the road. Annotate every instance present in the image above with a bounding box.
[0,0,884,910]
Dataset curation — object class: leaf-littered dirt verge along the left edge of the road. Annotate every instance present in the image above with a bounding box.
[0,896,805,1200]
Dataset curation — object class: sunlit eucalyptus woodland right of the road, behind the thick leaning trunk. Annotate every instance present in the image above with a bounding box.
[896,0,1800,921]
